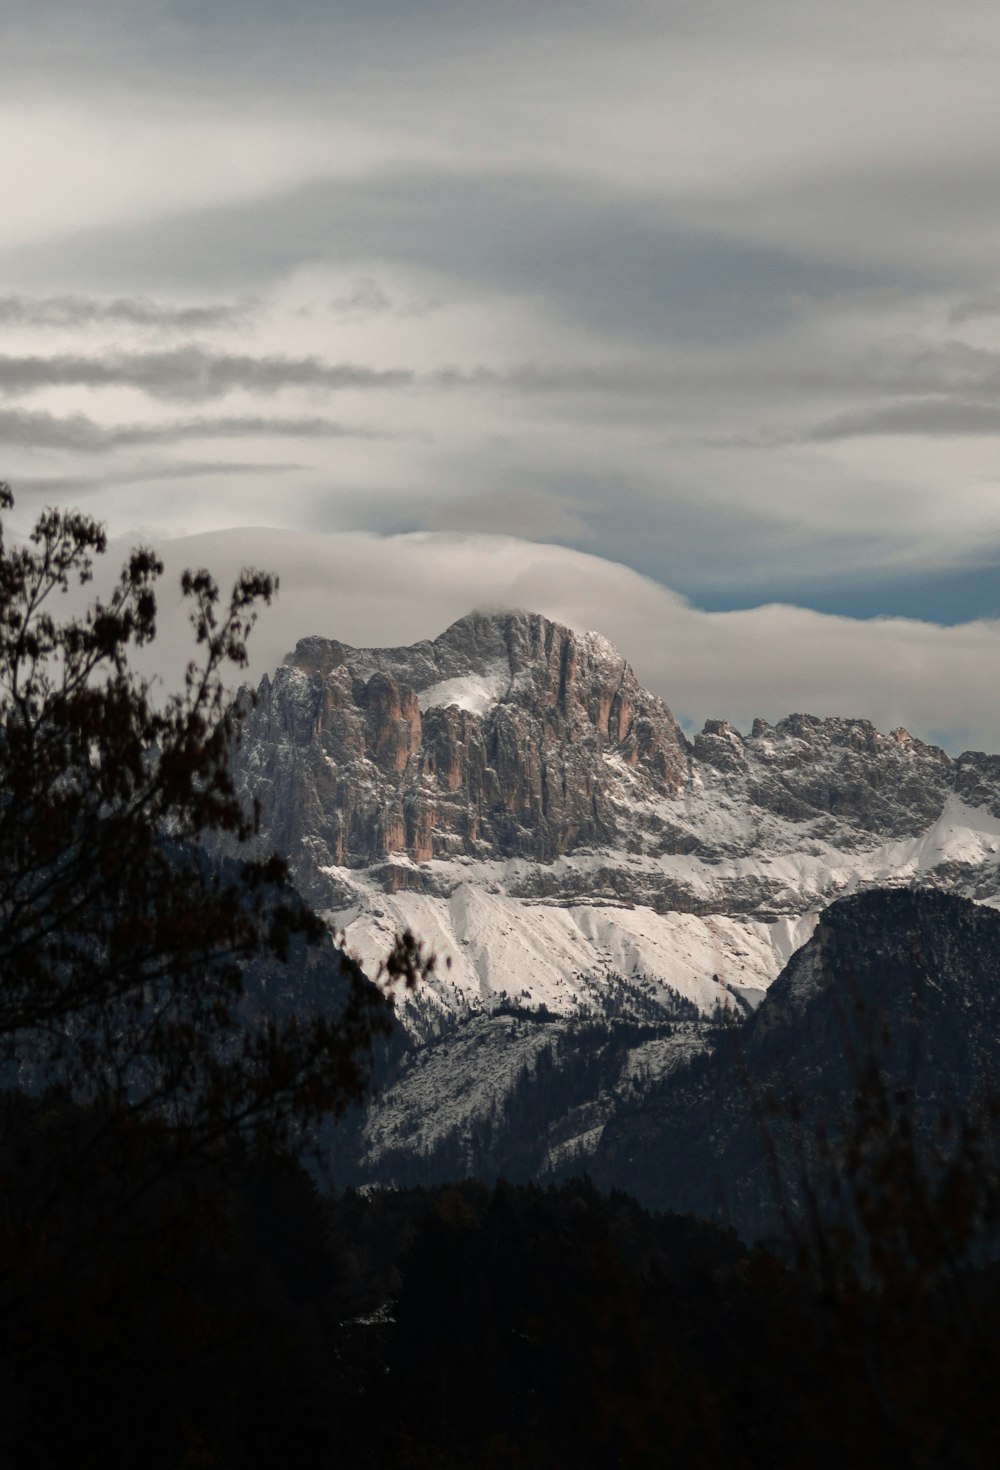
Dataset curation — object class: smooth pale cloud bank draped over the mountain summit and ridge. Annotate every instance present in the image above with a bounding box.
[99,529,1000,750]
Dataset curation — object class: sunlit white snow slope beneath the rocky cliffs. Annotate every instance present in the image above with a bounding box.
[328,797,1000,1014]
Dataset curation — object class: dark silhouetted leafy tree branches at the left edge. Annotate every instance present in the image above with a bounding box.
[0,484,388,1205]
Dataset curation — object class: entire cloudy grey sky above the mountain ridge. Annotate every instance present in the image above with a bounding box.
[0,0,1000,748]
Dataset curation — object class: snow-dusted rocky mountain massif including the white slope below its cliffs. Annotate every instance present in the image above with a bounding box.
[235,613,1000,1036]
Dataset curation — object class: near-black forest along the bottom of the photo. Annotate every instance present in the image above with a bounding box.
[11,1164,1000,1470]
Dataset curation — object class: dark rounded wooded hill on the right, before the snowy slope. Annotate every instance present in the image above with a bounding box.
[591,889,1000,1238]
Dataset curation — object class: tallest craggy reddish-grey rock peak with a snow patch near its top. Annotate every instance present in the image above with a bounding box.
[237,614,690,881]
